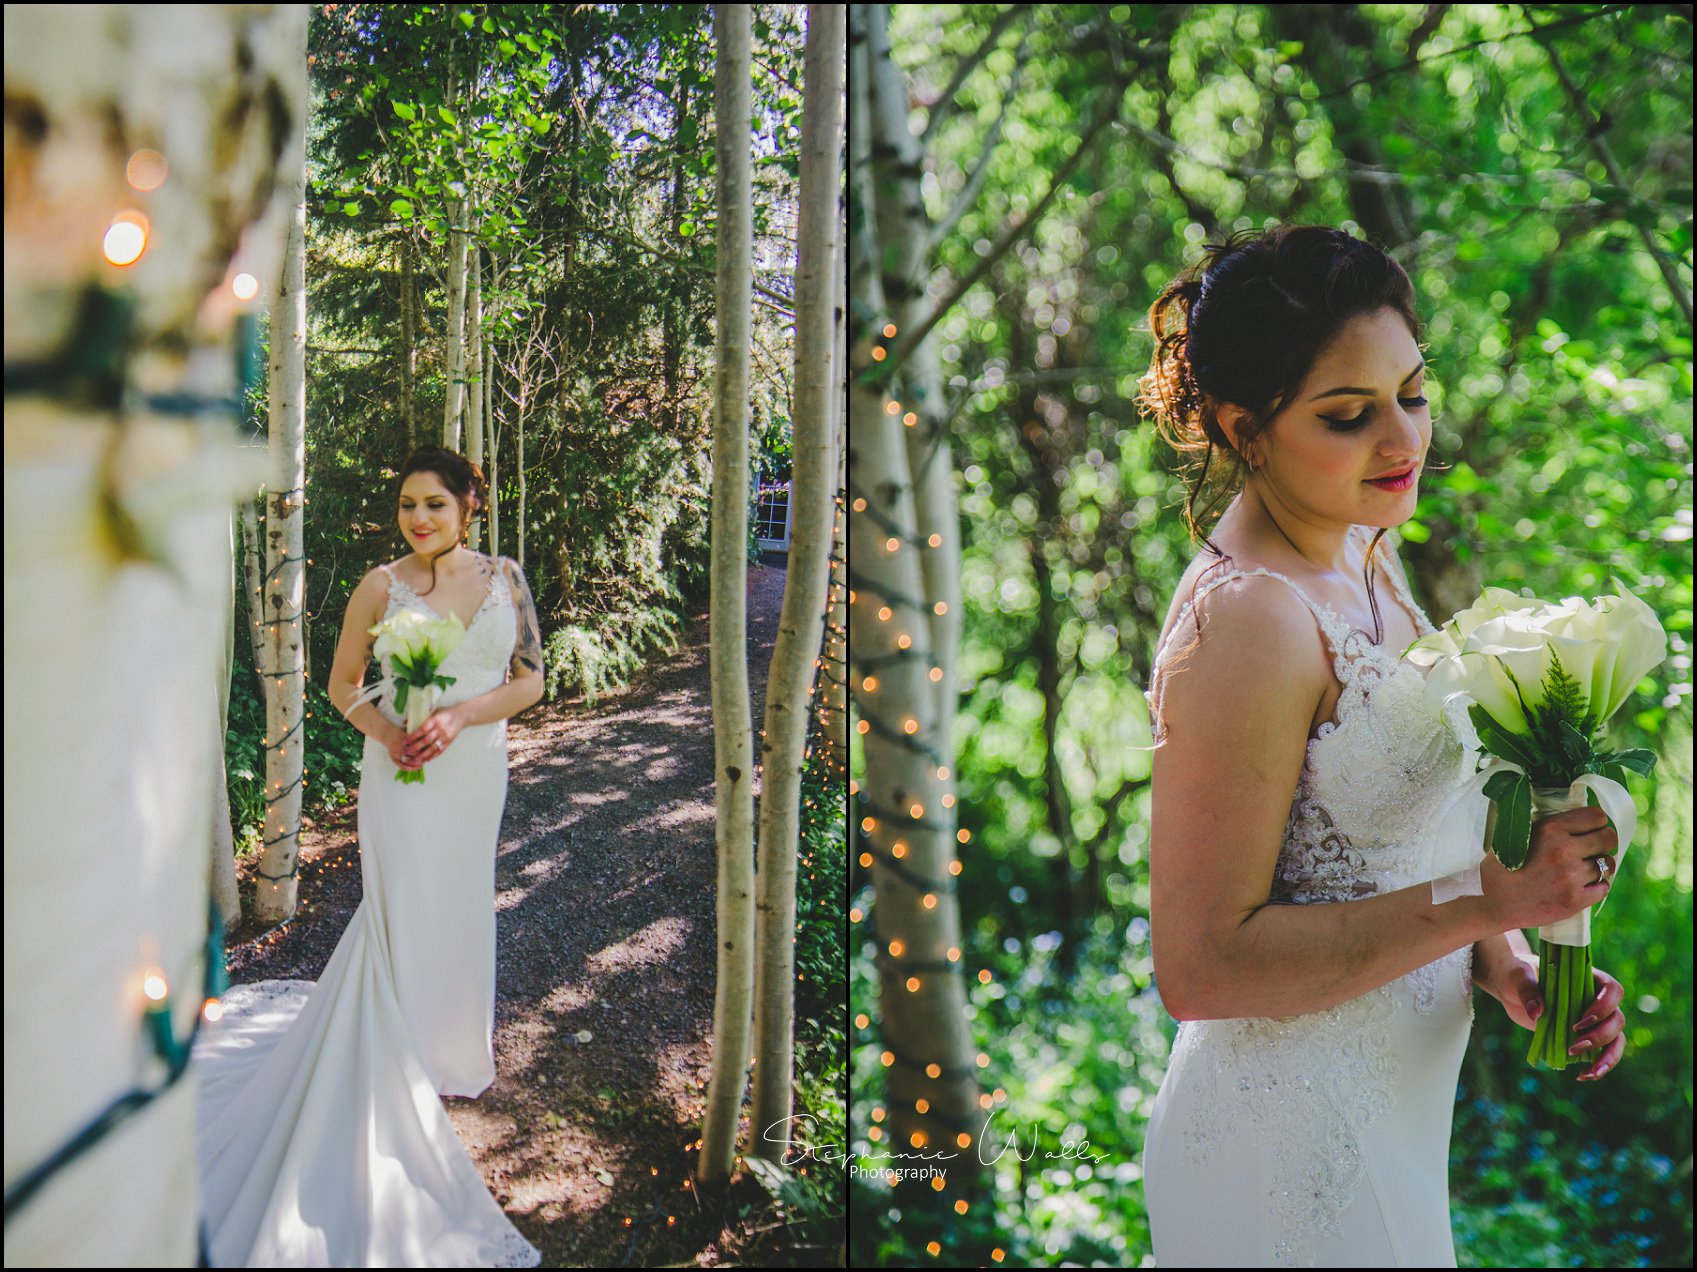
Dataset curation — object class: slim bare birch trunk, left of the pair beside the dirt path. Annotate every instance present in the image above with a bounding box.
[696,3,753,1186]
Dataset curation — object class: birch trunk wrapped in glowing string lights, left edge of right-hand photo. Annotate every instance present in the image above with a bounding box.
[849,5,984,1186]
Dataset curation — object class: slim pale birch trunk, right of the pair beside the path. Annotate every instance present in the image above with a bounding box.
[750,3,843,1162]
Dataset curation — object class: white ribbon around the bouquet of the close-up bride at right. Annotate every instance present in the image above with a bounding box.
[1432,758,1638,945]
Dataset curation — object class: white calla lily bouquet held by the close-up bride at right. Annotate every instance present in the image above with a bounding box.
[1405,580,1668,1068]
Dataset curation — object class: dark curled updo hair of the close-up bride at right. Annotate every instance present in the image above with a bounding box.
[1137,226,1420,641]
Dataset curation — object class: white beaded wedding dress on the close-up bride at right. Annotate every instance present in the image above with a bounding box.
[1144,529,1476,1267]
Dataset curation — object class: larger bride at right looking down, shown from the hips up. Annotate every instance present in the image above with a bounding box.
[1144,226,1626,1267]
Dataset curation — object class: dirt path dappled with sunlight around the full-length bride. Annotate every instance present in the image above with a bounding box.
[229,566,828,1267]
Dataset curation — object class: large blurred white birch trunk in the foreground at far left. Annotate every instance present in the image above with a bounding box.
[0,5,305,1267]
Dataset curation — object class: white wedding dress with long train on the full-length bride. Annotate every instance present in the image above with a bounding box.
[193,566,540,1267]
